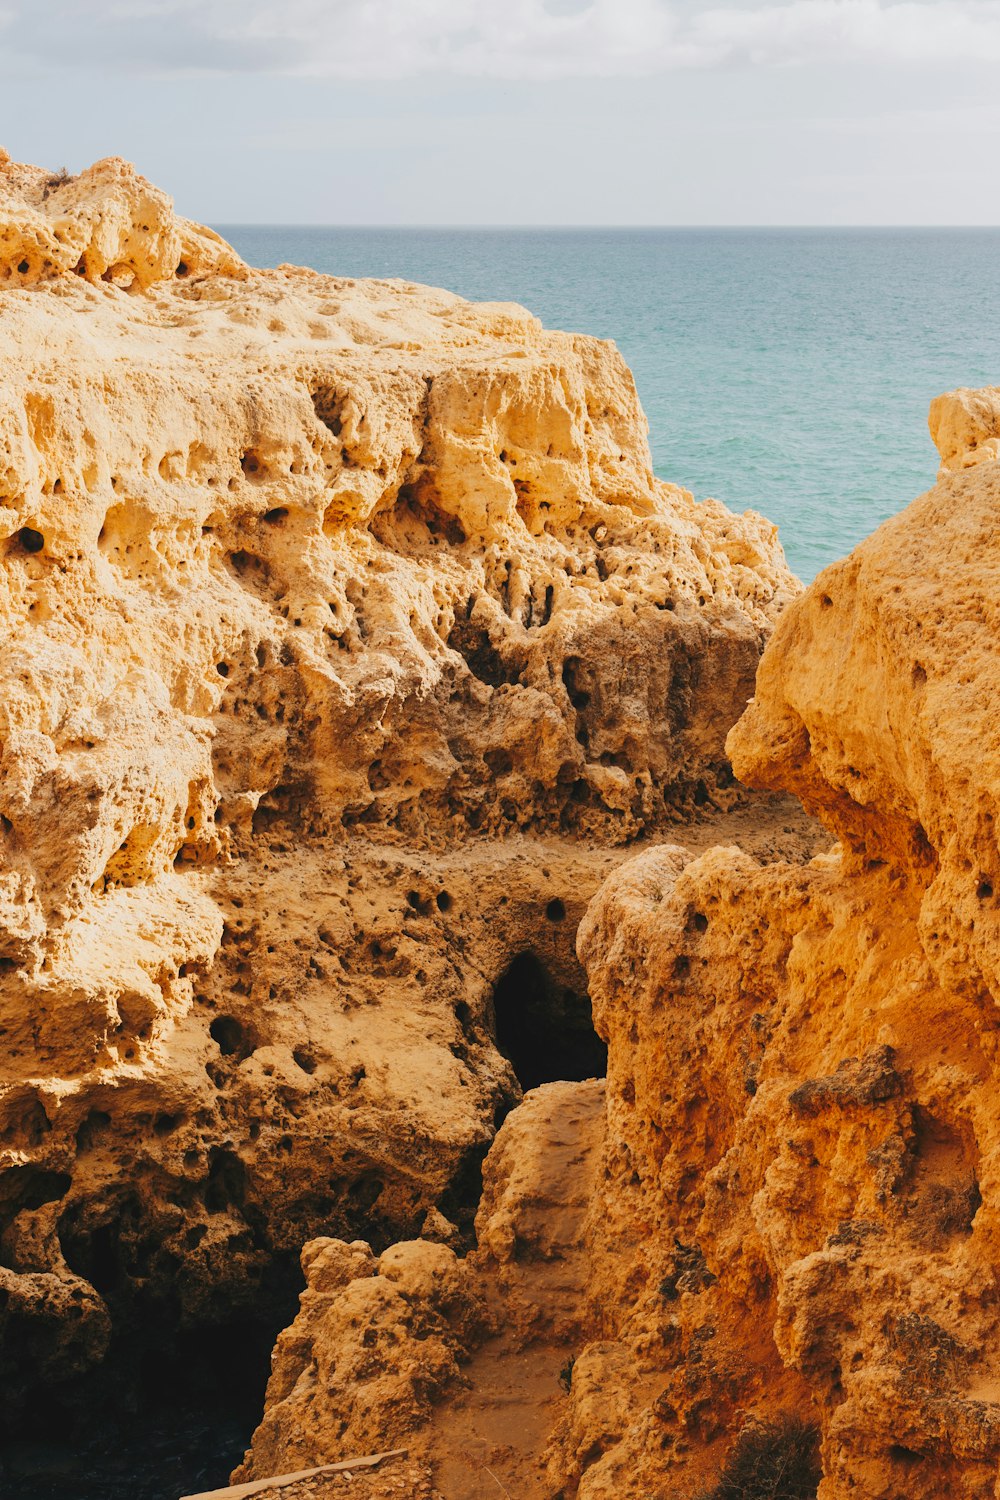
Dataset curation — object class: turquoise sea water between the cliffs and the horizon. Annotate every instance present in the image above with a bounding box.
[220,225,1000,579]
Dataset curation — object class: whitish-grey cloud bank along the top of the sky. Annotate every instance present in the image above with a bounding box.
[0,0,1000,81]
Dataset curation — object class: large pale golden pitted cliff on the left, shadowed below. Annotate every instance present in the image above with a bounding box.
[0,159,796,1416]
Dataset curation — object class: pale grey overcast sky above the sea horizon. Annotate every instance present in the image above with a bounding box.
[0,0,1000,225]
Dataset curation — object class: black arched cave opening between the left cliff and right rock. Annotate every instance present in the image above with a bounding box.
[493,953,607,1092]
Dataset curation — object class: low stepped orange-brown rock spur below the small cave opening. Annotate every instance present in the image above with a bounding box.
[234,1079,611,1500]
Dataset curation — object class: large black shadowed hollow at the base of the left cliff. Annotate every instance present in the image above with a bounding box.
[49,1206,301,1500]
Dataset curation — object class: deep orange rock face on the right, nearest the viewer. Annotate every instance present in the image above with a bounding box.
[248,408,1000,1500]
